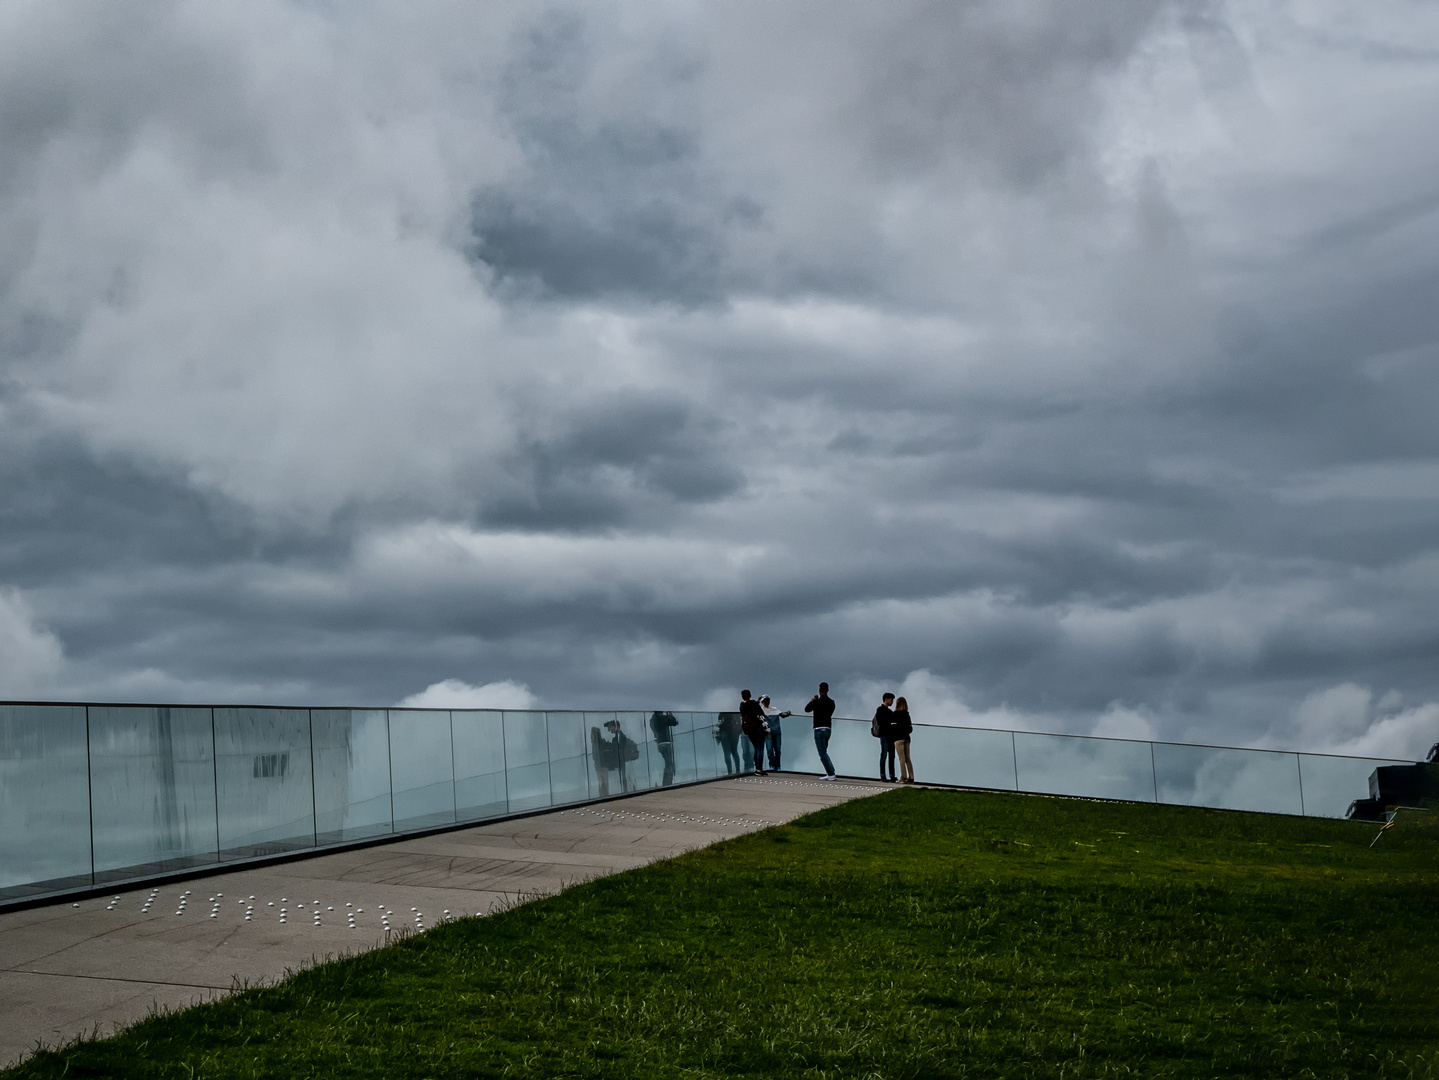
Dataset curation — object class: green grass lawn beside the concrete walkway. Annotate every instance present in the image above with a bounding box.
[6,790,1439,1079]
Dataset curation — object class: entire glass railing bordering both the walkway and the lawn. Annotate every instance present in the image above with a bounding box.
[0,705,1399,905]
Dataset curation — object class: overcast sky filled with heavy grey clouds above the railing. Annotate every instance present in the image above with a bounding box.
[0,0,1439,756]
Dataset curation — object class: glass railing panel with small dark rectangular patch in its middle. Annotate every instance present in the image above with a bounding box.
[214,708,315,859]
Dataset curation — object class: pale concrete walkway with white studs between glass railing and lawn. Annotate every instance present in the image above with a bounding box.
[0,774,891,1067]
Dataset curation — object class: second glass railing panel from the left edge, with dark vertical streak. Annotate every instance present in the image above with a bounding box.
[89,705,220,882]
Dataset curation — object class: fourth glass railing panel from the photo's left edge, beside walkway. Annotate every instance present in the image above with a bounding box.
[309,709,391,844]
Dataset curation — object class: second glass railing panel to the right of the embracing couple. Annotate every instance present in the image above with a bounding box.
[1014,732,1154,802]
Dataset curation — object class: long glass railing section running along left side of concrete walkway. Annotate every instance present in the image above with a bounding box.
[0,705,727,903]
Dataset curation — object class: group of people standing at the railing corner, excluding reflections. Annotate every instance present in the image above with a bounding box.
[715,683,914,784]
